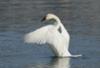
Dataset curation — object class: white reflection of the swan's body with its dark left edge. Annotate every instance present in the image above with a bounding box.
[50,58,70,68]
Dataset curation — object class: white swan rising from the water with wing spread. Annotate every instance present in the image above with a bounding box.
[25,13,81,57]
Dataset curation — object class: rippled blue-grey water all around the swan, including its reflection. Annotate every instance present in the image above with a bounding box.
[0,0,100,68]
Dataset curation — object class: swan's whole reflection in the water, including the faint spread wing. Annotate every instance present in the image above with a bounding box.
[24,58,70,68]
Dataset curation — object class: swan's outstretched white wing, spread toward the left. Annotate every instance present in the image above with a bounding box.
[24,25,54,44]
